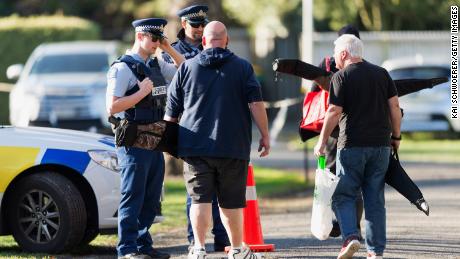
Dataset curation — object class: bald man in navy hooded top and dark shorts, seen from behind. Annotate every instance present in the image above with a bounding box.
[165,21,270,259]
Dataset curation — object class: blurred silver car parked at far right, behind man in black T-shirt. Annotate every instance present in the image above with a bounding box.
[382,56,460,132]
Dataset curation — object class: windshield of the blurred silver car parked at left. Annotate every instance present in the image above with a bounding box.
[30,53,109,74]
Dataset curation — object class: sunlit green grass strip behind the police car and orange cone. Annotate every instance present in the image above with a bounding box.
[0,167,308,259]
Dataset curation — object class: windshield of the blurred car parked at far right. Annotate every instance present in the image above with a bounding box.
[389,66,450,80]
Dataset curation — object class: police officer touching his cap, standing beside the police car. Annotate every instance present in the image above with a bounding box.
[106,18,184,259]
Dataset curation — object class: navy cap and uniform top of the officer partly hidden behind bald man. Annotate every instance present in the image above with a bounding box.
[162,5,208,63]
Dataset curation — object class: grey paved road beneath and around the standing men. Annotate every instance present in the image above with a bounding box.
[157,143,460,259]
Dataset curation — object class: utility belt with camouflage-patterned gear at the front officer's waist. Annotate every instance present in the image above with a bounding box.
[109,116,179,157]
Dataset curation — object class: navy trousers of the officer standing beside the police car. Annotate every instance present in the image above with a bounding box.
[117,147,164,256]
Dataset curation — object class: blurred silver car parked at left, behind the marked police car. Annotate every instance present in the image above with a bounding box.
[7,41,118,130]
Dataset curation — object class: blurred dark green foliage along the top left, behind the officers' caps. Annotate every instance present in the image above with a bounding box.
[0,0,241,39]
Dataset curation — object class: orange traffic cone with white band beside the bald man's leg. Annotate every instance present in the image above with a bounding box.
[243,163,275,252]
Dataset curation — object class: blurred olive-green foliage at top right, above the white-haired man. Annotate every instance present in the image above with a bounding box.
[314,0,460,31]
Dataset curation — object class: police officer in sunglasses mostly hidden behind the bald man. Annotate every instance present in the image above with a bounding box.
[163,5,230,251]
